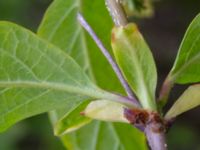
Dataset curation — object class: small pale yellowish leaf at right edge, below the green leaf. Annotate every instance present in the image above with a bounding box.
[165,84,200,119]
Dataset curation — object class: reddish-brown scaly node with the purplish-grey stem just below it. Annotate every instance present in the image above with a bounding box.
[124,109,168,150]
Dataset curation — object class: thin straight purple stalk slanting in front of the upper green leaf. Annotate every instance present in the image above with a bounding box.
[77,13,140,106]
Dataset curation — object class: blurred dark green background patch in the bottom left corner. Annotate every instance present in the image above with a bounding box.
[0,115,64,150]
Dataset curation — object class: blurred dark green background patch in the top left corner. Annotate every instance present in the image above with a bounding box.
[0,0,52,31]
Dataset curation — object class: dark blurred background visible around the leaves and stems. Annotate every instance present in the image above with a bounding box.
[0,0,200,150]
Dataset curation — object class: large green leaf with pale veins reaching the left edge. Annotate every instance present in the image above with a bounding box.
[0,22,118,131]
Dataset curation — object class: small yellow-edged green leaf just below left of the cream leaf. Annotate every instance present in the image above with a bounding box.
[52,101,91,136]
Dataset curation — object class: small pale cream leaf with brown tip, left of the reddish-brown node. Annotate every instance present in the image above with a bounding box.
[83,100,128,123]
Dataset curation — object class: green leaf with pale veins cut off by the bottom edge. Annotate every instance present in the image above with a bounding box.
[62,121,147,150]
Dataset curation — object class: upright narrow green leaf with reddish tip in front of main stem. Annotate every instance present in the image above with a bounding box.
[112,24,157,110]
